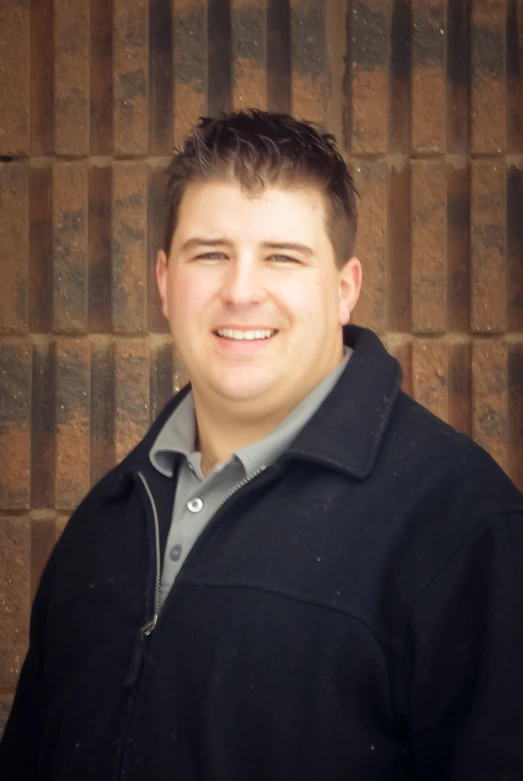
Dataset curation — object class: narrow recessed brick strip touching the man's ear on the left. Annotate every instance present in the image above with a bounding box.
[147,168,169,333]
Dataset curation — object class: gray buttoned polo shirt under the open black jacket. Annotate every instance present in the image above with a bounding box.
[150,347,352,605]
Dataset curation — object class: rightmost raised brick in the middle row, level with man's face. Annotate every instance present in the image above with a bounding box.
[471,162,507,332]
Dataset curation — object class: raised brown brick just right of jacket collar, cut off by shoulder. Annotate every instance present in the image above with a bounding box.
[412,341,449,421]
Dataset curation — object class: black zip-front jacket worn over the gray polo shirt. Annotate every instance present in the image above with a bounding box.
[0,327,523,781]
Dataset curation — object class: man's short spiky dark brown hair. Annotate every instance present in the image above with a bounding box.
[164,109,358,266]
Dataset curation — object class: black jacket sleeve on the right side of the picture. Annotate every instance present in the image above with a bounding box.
[402,512,523,781]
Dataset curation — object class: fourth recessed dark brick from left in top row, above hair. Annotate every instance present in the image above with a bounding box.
[207,0,232,116]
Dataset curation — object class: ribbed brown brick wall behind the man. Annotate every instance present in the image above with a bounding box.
[0,0,523,722]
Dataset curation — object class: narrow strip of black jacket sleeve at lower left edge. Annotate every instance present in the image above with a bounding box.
[0,549,56,781]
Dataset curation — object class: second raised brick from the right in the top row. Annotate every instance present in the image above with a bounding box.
[412,0,447,153]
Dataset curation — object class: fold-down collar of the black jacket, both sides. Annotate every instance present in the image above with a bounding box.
[102,325,401,502]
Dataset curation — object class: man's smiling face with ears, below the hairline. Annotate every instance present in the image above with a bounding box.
[157,181,361,415]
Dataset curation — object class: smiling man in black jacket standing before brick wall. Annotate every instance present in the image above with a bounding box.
[0,111,523,781]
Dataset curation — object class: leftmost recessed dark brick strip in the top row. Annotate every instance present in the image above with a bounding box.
[30,0,54,155]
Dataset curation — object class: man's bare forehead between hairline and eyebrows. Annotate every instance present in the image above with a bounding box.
[175,181,325,243]
